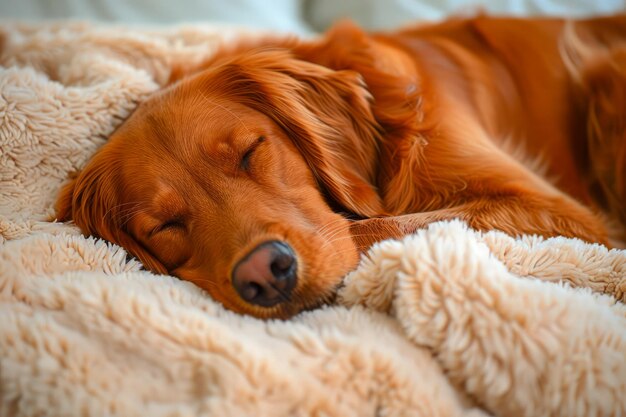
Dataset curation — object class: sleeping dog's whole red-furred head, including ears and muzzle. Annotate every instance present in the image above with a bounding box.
[57,49,384,317]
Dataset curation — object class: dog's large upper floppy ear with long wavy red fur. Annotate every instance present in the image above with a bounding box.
[206,49,385,217]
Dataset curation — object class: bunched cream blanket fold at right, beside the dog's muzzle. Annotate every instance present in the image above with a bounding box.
[342,222,626,416]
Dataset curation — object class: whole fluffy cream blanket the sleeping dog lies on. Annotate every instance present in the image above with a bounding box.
[0,23,626,417]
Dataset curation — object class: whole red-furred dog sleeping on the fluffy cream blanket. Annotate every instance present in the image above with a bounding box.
[57,16,626,317]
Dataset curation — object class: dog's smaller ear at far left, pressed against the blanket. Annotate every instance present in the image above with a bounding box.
[55,151,167,274]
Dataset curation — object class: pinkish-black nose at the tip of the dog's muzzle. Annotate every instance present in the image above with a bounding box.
[232,241,297,307]
